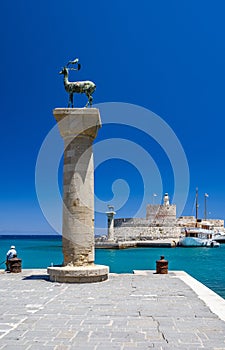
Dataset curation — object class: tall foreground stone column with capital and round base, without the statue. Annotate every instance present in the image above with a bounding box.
[48,108,109,283]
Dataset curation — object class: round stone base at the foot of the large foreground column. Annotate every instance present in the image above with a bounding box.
[47,265,109,283]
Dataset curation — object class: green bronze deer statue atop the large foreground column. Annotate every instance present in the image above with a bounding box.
[59,58,96,108]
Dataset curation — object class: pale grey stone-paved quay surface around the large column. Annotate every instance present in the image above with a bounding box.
[0,270,225,350]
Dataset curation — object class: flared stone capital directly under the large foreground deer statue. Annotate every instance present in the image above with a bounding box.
[53,108,102,139]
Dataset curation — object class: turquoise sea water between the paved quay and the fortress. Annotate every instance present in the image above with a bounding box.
[0,236,225,298]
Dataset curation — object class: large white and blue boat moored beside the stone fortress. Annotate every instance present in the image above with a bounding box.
[178,227,220,248]
